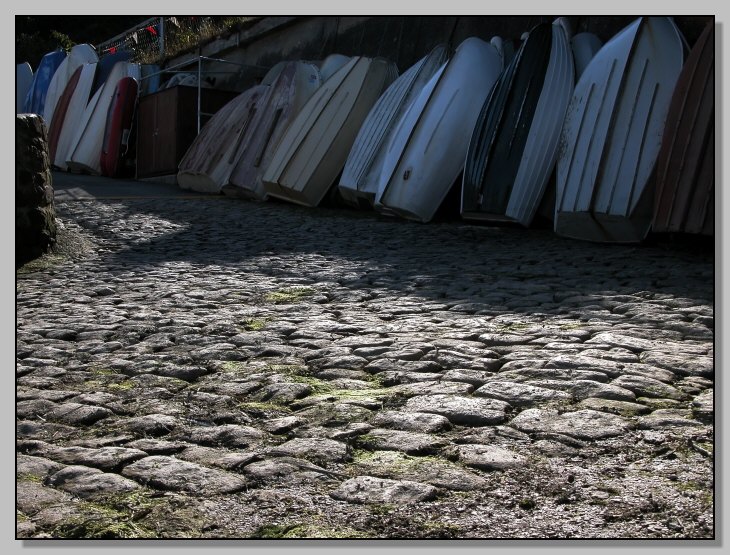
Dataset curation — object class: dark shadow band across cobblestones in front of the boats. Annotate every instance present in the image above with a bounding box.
[54,172,714,324]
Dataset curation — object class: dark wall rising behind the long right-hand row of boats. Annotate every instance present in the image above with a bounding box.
[170,16,713,91]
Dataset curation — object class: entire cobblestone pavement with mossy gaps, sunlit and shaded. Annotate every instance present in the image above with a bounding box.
[16,192,714,538]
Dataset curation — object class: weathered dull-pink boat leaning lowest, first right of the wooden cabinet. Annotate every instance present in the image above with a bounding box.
[177,85,269,193]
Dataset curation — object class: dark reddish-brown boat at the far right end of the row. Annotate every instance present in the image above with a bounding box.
[652,22,715,235]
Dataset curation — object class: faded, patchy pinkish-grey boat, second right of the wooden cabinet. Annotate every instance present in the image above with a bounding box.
[223,62,322,200]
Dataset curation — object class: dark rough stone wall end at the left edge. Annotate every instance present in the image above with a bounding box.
[15,114,56,267]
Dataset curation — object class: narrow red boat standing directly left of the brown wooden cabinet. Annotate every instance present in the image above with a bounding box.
[100,77,137,177]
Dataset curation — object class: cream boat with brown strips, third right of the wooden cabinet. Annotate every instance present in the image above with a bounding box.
[263,56,397,206]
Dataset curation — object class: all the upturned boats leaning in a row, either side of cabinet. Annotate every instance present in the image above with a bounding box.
[17,17,715,242]
